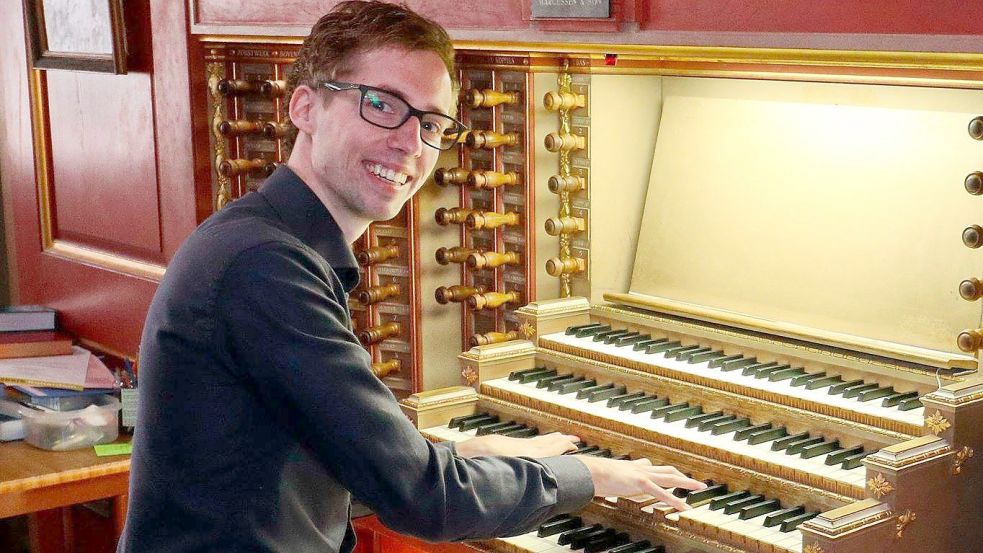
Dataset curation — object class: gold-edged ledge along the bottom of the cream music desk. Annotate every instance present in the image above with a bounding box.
[604,293,978,369]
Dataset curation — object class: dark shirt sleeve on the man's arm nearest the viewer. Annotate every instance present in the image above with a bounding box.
[218,243,594,541]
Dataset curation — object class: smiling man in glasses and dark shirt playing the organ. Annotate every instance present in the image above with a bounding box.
[119,1,703,553]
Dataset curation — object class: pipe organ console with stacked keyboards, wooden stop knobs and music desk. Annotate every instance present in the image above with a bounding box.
[199,35,983,553]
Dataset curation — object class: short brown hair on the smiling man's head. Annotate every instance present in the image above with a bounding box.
[282,0,457,148]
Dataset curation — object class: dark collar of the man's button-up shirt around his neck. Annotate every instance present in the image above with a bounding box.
[259,165,359,292]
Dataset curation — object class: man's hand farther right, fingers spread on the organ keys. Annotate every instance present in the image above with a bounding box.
[576,455,707,511]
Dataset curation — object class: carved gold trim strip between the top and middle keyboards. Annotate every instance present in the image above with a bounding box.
[539,338,922,440]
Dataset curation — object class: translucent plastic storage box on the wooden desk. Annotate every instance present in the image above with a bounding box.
[19,396,120,451]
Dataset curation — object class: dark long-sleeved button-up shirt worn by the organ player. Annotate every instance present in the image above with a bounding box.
[119,167,593,553]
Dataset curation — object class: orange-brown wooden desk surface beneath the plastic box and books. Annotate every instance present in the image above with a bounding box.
[0,436,130,518]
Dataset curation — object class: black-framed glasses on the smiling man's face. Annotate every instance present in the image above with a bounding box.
[318,81,468,150]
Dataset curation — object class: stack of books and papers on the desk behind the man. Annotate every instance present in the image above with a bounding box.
[0,306,116,441]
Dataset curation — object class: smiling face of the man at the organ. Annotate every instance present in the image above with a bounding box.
[308,47,453,224]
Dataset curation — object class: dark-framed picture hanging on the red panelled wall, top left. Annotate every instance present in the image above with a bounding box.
[23,0,126,74]
